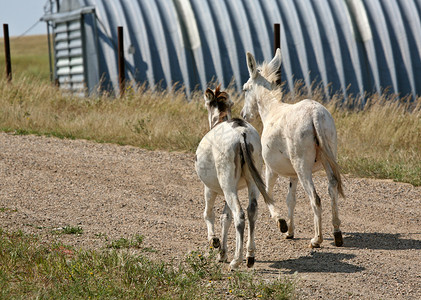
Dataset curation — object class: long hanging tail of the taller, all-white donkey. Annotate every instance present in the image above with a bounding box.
[313,121,345,198]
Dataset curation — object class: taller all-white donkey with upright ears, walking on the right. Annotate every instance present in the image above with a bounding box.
[241,49,344,247]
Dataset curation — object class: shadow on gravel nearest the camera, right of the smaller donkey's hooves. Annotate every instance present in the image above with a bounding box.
[269,252,365,274]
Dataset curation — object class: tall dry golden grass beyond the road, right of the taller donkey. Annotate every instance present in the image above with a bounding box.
[276,83,421,186]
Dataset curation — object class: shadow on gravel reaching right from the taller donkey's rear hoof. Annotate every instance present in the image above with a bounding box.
[344,232,421,250]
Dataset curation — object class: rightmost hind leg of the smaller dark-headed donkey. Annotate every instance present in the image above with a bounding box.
[246,183,260,268]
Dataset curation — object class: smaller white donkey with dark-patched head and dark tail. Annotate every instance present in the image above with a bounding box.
[196,87,288,269]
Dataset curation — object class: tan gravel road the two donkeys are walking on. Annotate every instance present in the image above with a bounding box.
[0,133,421,299]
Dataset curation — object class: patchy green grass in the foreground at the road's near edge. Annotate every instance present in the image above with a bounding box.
[0,228,294,299]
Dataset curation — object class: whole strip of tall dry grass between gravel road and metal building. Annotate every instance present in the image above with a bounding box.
[0,78,421,185]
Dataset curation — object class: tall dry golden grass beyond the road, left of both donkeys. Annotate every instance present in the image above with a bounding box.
[0,79,207,151]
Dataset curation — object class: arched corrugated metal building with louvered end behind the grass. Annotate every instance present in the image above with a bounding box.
[43,0,421,97]
